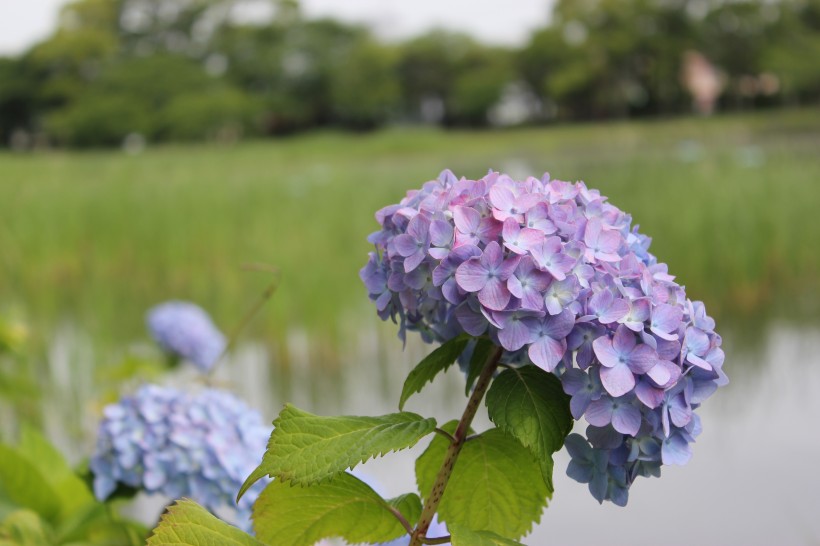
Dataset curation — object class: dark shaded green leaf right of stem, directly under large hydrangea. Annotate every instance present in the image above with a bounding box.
[486,365,572,490]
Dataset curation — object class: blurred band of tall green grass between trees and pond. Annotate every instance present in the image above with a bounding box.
[0,110,820,352]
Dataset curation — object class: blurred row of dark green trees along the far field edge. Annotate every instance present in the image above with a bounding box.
[0,0,820,148]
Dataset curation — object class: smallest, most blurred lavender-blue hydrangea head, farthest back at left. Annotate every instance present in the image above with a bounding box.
[146,301,226,372]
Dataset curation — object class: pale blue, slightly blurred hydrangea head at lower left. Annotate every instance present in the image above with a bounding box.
[90,385,271,529]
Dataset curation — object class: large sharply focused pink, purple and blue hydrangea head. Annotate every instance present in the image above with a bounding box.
[360,171,728,505]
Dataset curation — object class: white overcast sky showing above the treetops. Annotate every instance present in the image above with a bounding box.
[0,0,551,55]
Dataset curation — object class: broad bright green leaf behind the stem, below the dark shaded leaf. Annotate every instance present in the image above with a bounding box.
[416,427,547,537]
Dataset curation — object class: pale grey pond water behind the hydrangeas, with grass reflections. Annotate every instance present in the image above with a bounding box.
[25,318,820,546]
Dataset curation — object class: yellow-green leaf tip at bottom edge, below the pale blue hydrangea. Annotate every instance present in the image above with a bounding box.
[146,499,262,546]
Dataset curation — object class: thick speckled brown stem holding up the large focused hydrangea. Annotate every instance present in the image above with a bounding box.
[410,347,503,546]
